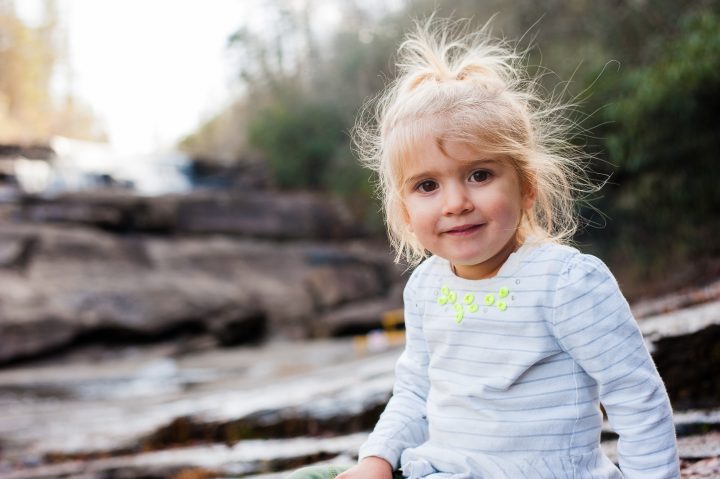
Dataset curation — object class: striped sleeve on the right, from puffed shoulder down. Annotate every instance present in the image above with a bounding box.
[553,254,680,479]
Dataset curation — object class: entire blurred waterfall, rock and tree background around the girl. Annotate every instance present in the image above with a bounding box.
[0,0,720,479]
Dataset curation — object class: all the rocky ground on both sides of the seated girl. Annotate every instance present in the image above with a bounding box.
[0,191,720,479]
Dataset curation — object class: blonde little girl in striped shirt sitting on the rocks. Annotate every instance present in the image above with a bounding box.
[291,16,680,479]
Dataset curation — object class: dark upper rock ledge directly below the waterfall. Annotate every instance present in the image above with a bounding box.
[22,190,362,240]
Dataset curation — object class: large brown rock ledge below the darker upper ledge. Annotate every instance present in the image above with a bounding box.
[0,224,400,362]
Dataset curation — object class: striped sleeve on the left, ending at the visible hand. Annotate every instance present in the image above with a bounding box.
[359,266,430,469]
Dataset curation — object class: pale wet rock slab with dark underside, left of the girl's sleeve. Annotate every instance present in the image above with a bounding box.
[0,339,399,464]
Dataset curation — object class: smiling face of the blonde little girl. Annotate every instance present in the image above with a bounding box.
[402,137,535,279]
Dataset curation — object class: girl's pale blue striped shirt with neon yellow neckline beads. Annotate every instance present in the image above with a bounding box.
[359,243,680,479]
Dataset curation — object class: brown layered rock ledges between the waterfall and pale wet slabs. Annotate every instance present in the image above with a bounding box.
[0,192,403,364]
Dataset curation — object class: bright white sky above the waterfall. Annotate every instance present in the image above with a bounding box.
[16,0,316,152]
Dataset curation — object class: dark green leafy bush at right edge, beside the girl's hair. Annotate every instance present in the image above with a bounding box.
[584,11,720,282]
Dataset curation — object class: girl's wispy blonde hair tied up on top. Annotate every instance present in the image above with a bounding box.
[353,18,589,265]
